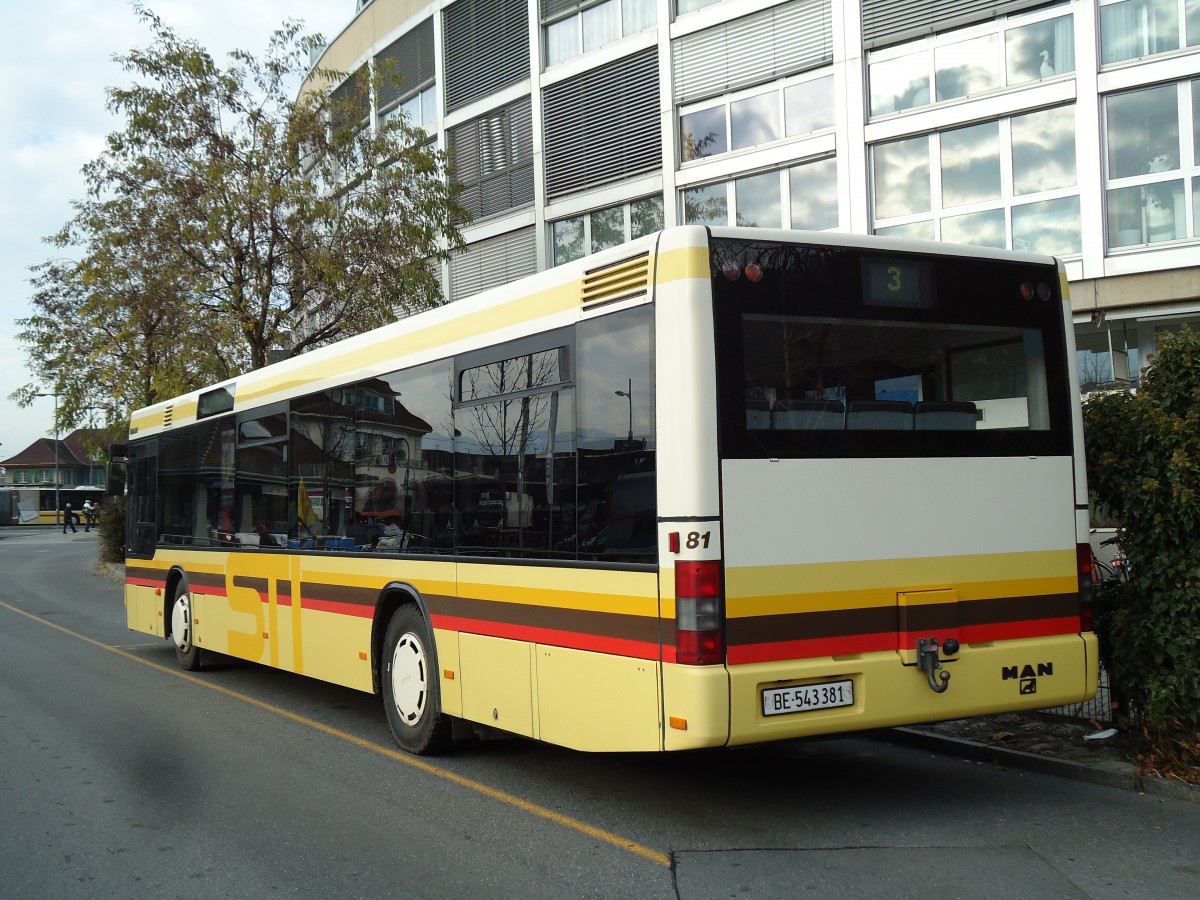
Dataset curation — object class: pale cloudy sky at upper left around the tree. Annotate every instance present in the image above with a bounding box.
[0,0,356,460]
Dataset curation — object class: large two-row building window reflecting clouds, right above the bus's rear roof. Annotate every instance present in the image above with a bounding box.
[871,106,1082,256]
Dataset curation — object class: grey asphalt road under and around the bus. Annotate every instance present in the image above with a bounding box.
[0,528,1200,900]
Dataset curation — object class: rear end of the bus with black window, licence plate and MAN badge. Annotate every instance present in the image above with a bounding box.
[664,229,1097,746]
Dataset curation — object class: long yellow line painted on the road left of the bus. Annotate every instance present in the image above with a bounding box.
[0,600,671,868]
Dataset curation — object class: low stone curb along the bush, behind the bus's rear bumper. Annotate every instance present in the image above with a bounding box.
[876,728,1200,803]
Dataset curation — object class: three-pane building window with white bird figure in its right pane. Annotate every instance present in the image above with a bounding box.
[868,11,1075,115]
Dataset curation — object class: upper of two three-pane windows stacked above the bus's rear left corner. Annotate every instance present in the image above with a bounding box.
[679,74,834,162]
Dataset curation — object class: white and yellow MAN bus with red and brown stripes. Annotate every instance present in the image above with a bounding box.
[126,227,1097,752]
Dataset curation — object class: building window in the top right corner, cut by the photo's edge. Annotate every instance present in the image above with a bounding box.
[1100,0,1200,65]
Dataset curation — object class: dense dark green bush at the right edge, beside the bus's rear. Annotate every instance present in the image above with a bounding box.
[1084,328,1200,764]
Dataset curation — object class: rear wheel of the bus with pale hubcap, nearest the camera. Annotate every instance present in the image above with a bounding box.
[382,606,450,755]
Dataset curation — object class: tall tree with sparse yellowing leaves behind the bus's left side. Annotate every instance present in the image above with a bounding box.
[13,4,468,427]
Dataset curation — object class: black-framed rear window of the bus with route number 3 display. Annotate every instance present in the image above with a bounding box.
[713,241,1070,457]
